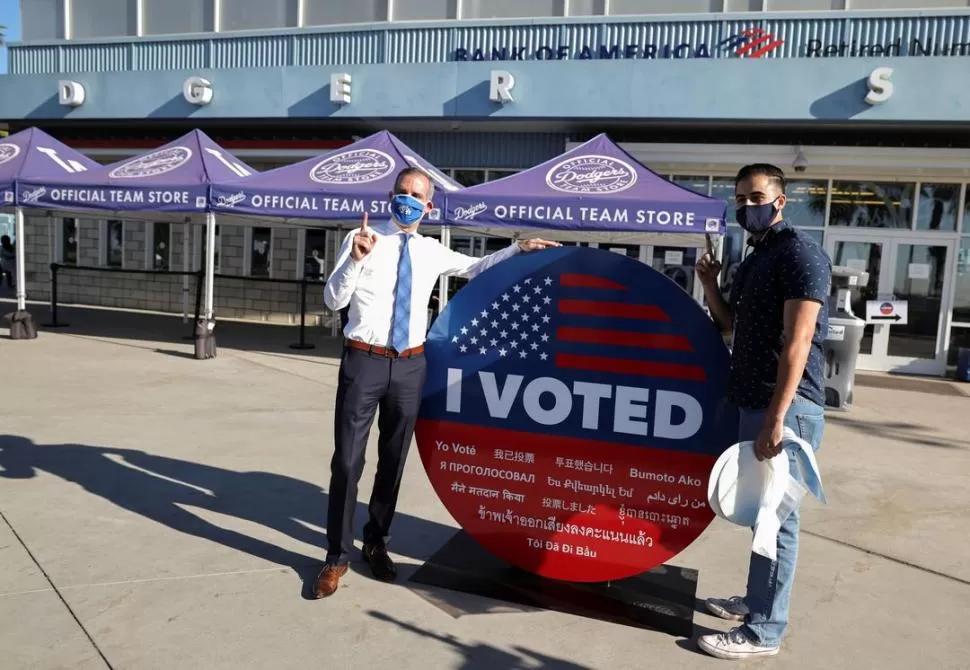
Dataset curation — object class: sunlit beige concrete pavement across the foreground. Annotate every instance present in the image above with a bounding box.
[0,310,970,670]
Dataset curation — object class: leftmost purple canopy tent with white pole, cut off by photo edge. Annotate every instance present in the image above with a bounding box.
[0,128,100,326]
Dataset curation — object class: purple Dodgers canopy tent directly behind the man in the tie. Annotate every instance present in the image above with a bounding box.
[211,130,461,225]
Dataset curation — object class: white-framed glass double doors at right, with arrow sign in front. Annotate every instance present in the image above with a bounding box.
[827,231,956,375]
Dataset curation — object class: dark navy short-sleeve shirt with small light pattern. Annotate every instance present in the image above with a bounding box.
[728,221,832,409]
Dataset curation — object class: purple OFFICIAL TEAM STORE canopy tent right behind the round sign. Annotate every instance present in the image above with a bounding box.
[445,133,725,246]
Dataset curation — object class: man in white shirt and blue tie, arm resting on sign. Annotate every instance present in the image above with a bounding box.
[314,167,558,598]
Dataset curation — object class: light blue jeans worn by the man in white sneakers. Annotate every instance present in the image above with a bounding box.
[738,396,825,647]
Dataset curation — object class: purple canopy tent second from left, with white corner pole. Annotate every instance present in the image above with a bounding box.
[17,130,256,320]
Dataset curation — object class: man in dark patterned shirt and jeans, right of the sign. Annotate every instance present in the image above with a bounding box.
[697,164,832,659]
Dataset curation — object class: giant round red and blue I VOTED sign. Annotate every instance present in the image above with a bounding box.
[416,247,737,582]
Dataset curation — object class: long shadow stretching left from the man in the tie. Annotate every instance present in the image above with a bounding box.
[0,435,455,598]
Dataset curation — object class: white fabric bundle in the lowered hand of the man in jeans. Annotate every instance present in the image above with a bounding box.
[707,427,825,561]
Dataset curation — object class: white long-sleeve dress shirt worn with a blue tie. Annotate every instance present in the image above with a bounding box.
[323,221,519,349]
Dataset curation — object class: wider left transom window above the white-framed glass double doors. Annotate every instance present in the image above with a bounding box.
[829,181,916,229]
